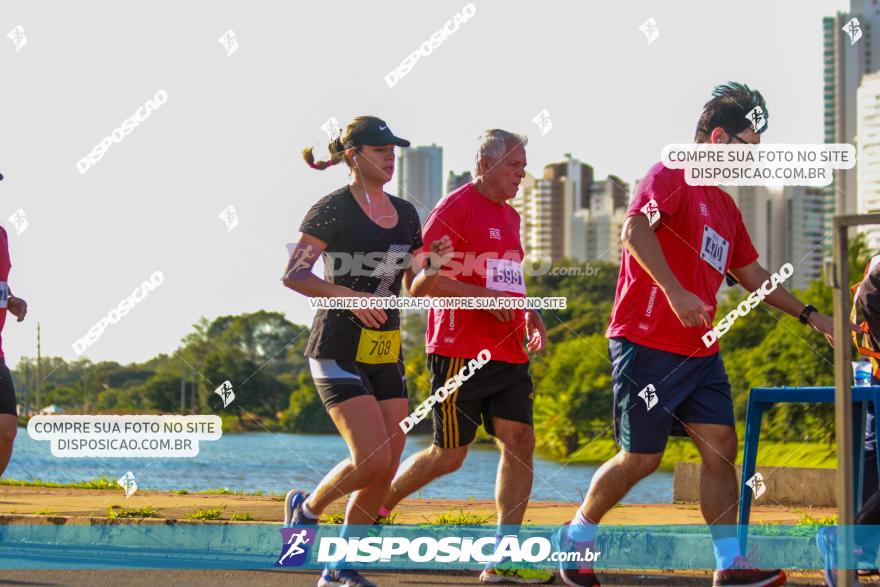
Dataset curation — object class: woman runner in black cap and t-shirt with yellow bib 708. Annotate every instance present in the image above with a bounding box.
[283,116,452,587]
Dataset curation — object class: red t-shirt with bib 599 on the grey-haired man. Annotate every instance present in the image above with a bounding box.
[422,183,529,363]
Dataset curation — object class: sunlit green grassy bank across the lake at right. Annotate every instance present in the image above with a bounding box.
[548,438,837,471]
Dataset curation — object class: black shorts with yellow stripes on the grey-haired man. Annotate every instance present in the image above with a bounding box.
[428,354,534,448]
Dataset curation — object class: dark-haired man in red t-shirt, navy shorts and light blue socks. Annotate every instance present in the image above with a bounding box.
[557,82,832,587]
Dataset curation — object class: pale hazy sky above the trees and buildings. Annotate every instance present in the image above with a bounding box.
[0,0,847,365]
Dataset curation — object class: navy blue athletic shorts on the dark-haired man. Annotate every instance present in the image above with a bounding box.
[608,337,734,453]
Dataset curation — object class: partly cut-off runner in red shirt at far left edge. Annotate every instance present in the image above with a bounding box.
[0,169,27,476]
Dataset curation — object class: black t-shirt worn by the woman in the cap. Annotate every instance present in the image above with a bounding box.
[299,186,422,361]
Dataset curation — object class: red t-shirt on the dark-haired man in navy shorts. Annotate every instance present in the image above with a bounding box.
[605,163,758,357]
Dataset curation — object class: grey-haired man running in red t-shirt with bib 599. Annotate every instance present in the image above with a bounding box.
[380,129,553,583]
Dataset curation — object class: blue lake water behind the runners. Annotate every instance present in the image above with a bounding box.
[0,428,672,503]
